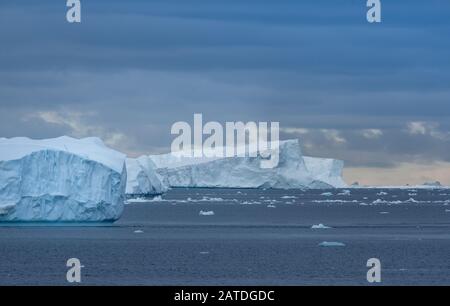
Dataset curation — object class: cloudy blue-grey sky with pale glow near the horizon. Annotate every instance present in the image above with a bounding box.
[0,0,450,185]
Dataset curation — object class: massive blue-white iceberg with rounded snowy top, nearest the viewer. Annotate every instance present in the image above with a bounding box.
[0,137,126,222]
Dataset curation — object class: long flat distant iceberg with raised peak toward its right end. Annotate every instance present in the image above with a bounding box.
[150,140,346,189]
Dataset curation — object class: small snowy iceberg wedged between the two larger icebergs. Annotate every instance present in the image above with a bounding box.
[126,156,168,196]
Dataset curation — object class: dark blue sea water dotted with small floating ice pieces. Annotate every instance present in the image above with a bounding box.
[0,189,450,285]
